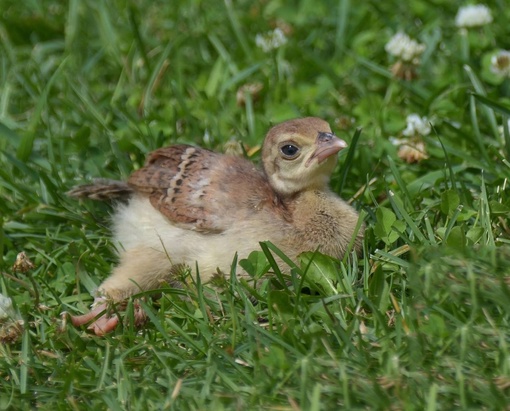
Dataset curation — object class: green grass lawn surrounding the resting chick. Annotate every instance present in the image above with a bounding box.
[0,0,510,411]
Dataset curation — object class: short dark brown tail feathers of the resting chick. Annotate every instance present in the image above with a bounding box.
[67,178,133,201]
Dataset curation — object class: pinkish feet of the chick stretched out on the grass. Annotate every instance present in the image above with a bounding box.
[71,297,147,336]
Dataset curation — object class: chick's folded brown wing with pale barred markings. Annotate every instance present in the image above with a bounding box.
[128,145,290,233]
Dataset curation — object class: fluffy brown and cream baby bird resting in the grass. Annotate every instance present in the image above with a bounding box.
[70,117,363,335]
